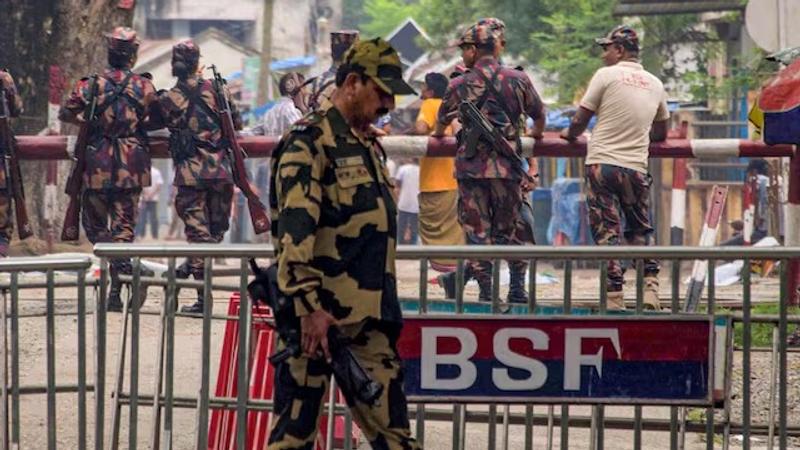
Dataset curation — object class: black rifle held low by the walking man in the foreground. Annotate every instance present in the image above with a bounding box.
[247,258,383,405]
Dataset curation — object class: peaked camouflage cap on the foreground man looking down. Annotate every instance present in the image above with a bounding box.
[344,38,416,95]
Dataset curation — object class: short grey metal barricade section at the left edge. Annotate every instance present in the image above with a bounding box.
[0,257,94,449]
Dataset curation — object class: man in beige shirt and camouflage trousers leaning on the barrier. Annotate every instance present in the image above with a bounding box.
[561,25,669,309]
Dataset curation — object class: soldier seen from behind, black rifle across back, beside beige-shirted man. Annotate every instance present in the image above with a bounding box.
[436,18,544,303]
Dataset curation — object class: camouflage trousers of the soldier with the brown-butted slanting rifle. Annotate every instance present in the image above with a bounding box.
[175,183,233,277]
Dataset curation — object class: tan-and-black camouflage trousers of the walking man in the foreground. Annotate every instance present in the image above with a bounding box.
[268,320,420,450]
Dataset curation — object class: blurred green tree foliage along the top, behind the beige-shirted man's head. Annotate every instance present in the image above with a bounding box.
[345,0,750,104]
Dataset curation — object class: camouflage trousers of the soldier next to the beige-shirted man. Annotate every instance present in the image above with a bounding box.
[458,178,533,283]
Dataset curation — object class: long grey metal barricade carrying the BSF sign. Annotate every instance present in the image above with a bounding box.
[83,244,800,449]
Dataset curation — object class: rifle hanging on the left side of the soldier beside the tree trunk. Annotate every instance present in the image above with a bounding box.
[61,74,97,241]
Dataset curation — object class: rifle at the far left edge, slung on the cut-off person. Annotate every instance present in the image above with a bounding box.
[0,76,33,239]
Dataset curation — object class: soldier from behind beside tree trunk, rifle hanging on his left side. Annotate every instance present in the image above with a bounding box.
[59,27,155,311]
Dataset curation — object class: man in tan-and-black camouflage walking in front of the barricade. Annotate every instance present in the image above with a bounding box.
[269,39,419,450]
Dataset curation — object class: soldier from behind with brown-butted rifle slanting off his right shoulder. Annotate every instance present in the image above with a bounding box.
[151,39,241,313]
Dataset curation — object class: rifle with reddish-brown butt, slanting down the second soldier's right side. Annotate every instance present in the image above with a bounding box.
[211,65,270,234]
